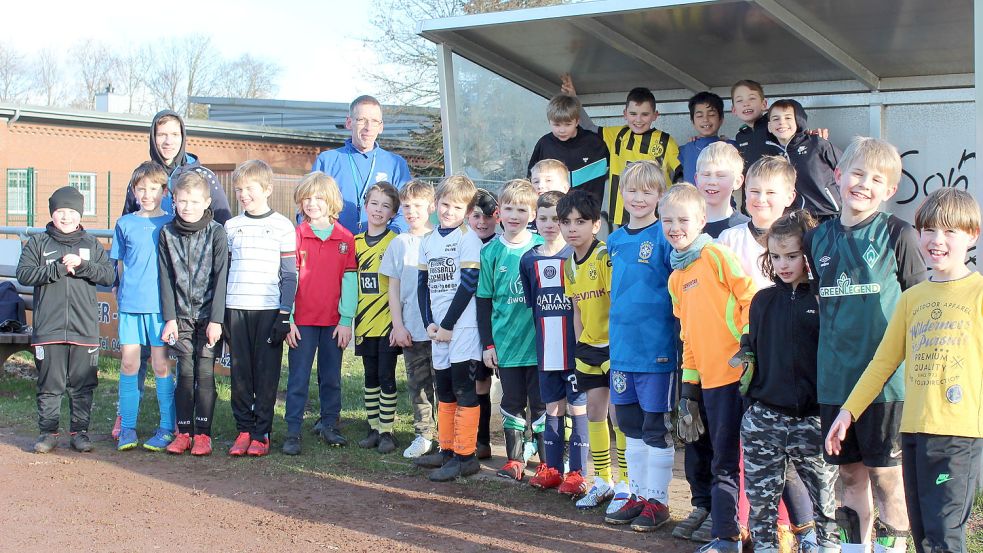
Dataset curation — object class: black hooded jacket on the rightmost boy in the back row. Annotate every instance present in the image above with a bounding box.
[764,100,842,217]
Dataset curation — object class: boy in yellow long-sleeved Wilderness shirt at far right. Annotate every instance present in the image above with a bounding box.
[826,188,983,553]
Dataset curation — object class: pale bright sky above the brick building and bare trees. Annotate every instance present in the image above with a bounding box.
[0,0,396,102]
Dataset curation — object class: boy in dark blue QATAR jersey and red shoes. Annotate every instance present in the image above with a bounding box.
[519,190,589,496]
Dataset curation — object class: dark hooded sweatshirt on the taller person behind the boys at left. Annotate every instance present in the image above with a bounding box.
[123,109,232,225]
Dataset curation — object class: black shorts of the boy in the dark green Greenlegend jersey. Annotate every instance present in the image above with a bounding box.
[819,401,904,468]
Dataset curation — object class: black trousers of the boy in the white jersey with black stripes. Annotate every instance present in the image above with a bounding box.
[225,309,283,441]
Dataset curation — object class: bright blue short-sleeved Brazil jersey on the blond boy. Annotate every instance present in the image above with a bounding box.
[607,221,679,373]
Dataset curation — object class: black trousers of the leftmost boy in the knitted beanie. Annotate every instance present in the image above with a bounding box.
[34,344,99,433]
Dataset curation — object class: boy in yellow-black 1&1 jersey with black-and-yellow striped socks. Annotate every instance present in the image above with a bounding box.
[355,182,401,453]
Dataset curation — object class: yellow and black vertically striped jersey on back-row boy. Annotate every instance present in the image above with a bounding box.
[598,125,679,225]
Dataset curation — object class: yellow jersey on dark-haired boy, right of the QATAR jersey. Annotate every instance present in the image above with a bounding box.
[563,240,611,347]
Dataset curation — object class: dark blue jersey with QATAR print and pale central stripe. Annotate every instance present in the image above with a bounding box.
[519,245,577,371]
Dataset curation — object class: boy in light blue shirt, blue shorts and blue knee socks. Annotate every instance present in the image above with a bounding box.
[109,161,175,451]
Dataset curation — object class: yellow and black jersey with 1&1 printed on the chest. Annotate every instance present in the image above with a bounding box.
[355,230,396,338]
